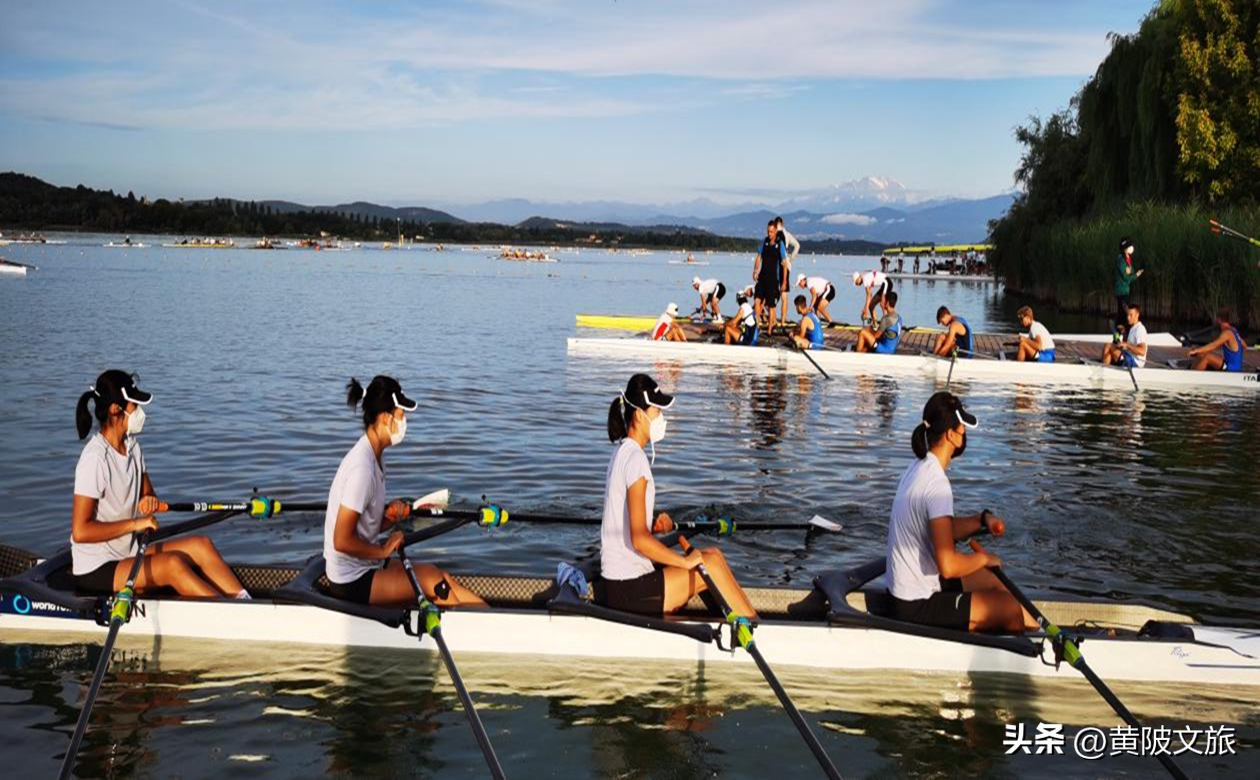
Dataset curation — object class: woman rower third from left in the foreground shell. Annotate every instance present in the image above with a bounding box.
[595,374,757,620]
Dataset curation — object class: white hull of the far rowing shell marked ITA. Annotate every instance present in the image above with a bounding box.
[568,338,1260,393]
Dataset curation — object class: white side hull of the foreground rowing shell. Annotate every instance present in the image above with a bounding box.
[0,600,1260,687]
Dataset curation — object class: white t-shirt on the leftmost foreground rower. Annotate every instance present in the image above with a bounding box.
[71,433,145,575]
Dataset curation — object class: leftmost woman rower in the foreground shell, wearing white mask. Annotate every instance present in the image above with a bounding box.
[71,369,249,599]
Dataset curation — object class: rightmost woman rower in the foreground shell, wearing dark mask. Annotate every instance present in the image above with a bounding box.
[887,392,1037,633]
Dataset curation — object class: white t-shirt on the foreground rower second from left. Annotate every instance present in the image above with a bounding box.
[324,433,386,585]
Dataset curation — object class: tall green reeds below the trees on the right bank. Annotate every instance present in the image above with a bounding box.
[989,203,1260,328]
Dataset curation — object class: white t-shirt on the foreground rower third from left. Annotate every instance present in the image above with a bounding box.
[600,437,656,580]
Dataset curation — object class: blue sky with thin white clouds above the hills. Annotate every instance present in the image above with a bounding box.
[0,0,1152,204]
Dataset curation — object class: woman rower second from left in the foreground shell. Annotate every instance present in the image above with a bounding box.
[324,376,485,606]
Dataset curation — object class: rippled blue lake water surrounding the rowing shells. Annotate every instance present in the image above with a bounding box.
[0,237,1260,777]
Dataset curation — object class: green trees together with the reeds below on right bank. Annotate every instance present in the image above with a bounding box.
[990,0,1260,324]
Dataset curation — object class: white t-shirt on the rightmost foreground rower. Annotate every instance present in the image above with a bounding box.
[888,452,954,601]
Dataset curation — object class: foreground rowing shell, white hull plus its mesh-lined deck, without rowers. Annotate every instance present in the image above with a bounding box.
[0,546,1260,687]
